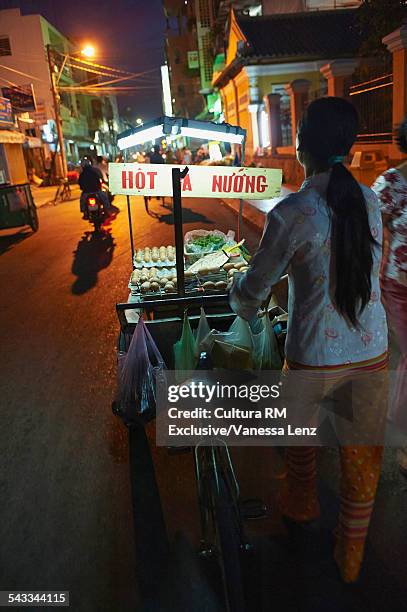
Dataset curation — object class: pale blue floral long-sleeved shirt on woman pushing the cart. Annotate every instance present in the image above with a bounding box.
[230,171,387,366]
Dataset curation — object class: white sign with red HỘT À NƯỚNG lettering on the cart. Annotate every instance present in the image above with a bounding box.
[109,164,282,200]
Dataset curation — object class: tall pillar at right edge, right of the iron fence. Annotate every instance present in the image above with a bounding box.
[383,24,407,159]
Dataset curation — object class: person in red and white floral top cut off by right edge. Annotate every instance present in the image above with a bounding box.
[372,116,407,476]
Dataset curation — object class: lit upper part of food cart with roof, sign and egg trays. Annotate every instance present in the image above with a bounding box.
[109,117,281,332]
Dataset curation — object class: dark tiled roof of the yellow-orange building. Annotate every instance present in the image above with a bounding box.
[236,10,361,59]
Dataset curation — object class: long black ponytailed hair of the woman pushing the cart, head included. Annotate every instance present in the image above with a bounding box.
[298,97,375,326]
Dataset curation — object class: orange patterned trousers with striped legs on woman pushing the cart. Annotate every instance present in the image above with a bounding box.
[280,359,387,582]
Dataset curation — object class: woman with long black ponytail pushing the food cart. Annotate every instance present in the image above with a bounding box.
[230,97,387,582]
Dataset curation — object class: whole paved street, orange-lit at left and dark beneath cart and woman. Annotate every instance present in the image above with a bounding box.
[0,192,407,612]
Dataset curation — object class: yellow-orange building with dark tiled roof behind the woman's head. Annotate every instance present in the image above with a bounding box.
[213,10,366,175]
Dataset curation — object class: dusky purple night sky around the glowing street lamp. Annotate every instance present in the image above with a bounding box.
[0,0,165,120]
